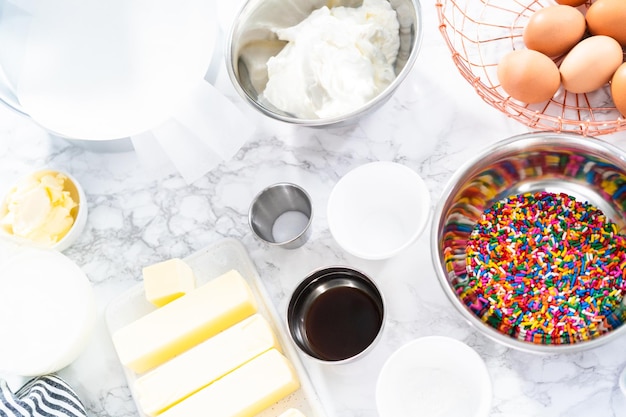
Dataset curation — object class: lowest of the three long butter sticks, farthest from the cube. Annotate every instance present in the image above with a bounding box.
[160,349,300,417]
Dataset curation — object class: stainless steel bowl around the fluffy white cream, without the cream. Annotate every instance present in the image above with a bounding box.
[225,0,422,126]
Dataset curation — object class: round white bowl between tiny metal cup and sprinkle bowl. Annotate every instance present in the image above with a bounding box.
[327,161,430,259]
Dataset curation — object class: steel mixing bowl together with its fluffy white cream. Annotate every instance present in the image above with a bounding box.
[225,0,422,126]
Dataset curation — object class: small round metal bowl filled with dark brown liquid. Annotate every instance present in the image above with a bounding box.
[287,266,385,364]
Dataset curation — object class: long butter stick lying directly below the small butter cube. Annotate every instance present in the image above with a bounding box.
[112,270,257,373]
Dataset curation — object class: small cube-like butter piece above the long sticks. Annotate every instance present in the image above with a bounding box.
[142,258,196,307]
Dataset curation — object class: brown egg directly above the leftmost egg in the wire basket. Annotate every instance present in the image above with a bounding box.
[523,5,585,57]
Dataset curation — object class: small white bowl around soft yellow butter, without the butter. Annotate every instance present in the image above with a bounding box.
[0,169,87,251]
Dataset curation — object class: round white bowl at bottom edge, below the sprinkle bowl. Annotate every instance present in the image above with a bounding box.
[376,336,492,417]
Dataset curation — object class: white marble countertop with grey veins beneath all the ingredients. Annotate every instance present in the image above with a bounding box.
[0,2,626,417]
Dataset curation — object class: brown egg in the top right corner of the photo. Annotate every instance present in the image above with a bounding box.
[586,0,626,46]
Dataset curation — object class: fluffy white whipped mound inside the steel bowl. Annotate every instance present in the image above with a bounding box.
[262,0,400,119]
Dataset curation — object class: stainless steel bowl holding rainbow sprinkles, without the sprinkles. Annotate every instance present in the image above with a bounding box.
[431,133,626,353]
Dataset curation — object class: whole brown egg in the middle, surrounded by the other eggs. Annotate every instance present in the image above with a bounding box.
[559,35,626,93]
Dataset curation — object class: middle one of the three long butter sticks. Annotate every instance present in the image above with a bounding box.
[134,314,280,416]
